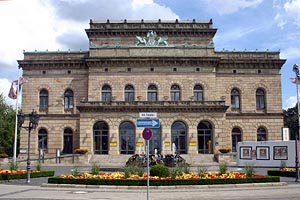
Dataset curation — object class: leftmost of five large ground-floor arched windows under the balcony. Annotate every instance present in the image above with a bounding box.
[93,121,109,154]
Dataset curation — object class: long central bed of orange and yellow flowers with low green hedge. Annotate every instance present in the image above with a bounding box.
[48,172,280,186]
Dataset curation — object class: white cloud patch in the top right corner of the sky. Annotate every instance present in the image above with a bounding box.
[274,0,300,28]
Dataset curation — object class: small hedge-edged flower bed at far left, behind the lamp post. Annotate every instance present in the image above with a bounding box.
[0,169,55,180]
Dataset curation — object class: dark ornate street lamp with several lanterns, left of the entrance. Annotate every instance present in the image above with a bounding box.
[18,110,40,183]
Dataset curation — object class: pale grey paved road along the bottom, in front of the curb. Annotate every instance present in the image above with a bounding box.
[0,184,300,200]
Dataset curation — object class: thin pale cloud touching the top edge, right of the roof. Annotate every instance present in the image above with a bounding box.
[206,0,263,15]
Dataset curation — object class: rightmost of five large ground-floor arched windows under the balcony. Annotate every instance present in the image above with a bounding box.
[197,121,213,154]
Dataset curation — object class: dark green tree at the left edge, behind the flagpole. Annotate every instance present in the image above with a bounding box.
[0,94,19,156]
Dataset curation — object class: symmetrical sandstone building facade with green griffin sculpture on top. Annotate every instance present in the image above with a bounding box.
[18,20,285,161]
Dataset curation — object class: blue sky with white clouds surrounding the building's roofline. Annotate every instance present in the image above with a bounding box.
[0,0,300,109]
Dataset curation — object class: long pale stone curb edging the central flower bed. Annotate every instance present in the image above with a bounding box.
[40,182,288,190]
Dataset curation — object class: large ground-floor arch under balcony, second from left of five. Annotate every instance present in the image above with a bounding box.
[119,122,135,154]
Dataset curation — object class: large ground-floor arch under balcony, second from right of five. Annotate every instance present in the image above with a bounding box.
[171,121,187,154]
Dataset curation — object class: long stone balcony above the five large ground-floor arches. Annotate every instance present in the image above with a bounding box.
[77,101,228,113]
